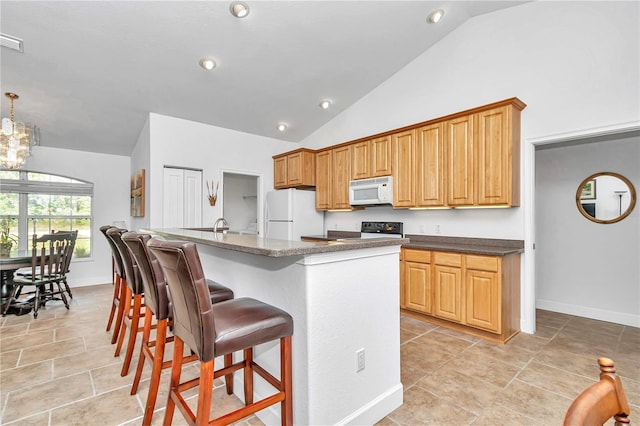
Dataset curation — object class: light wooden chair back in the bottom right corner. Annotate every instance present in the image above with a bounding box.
[564,358,630,426]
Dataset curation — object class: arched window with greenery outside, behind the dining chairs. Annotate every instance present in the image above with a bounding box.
[0,170,93,258]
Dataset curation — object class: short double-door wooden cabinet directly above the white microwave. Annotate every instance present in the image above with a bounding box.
[349,136,391,180]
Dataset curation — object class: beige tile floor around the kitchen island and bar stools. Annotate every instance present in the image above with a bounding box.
[0,285,640,426]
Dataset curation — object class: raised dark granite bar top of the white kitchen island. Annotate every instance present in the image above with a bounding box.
[140,228,409,257]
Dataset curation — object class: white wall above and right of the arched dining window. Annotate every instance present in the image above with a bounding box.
[26,146,131,288]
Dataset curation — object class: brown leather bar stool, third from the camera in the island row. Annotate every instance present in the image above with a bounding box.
[107,228,146,377]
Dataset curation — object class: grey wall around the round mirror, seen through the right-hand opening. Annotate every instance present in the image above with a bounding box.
[536,137,640,326]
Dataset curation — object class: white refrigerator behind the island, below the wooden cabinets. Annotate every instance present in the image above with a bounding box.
[264,189,324,241]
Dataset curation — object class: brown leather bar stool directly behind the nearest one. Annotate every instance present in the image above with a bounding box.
[122,232,233,426]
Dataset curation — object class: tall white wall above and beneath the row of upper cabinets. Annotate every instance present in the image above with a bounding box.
[302,1,640,332]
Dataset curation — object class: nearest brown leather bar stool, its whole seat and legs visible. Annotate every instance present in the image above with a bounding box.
[148,239,293,426]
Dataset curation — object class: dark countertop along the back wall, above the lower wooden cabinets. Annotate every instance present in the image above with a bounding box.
[402,234,524,256]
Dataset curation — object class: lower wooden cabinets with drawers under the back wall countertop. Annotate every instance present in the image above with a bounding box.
[400,248,520,342]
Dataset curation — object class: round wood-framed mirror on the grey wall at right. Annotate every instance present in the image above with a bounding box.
[576,172,636,223]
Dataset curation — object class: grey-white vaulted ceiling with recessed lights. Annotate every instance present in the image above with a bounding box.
[0,0,523,155]
